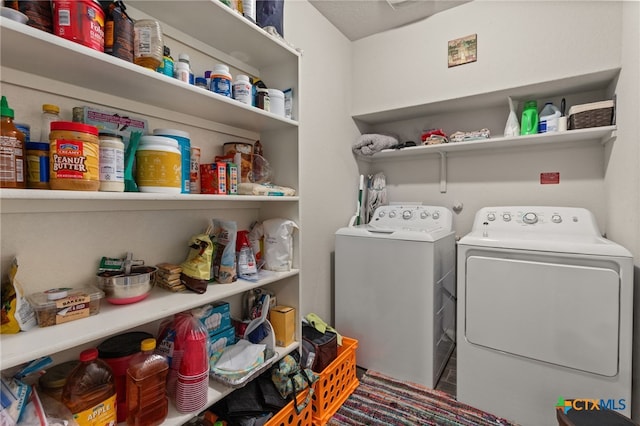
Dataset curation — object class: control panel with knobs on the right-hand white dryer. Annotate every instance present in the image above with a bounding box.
[473,206,600,235]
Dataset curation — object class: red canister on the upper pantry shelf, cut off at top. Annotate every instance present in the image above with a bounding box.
[53,0,104,52]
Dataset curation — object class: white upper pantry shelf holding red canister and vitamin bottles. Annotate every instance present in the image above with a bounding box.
[0,18,298,132]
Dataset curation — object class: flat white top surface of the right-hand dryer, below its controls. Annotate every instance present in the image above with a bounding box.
[458,231,631,257]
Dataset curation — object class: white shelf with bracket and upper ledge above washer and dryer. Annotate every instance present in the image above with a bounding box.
[352,68,620,193]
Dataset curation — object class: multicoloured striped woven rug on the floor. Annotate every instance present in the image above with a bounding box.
[328,370,515,426]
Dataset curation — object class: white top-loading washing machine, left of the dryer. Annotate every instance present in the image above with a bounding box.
[334,205,456,388]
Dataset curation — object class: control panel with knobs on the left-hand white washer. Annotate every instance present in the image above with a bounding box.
[368,204,453,232]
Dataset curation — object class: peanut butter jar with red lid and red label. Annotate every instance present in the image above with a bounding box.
[49,121,100,191]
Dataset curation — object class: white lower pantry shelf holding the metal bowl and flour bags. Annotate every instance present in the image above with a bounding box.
[0,269,300,370]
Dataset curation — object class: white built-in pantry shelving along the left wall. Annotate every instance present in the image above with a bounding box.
[0,0,301,425]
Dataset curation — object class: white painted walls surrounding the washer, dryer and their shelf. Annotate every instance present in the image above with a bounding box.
[285,0,640,421]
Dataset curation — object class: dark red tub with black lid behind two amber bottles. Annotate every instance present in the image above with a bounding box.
[98,331,153,423]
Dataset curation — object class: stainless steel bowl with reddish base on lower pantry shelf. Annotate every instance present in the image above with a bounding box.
[97,266,158,305]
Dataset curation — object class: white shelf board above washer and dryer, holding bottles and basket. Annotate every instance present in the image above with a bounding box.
[356,126,616,163]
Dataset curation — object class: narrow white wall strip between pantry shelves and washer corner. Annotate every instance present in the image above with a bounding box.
[283,1,359,322]
